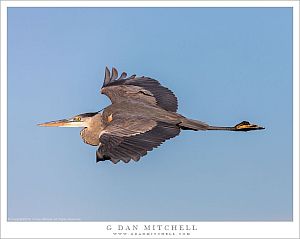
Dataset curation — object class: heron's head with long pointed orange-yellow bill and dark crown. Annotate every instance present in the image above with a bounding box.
[38,112,99,127]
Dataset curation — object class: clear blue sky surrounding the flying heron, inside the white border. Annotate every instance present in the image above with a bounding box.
[8,8,292,221]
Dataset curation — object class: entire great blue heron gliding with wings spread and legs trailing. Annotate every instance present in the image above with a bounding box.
[39,67,264,163]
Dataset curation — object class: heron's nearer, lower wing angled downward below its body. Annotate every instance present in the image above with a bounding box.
[96,118,180,163]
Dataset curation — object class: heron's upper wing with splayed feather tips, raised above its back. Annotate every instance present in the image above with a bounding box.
[101,67,178,112]
